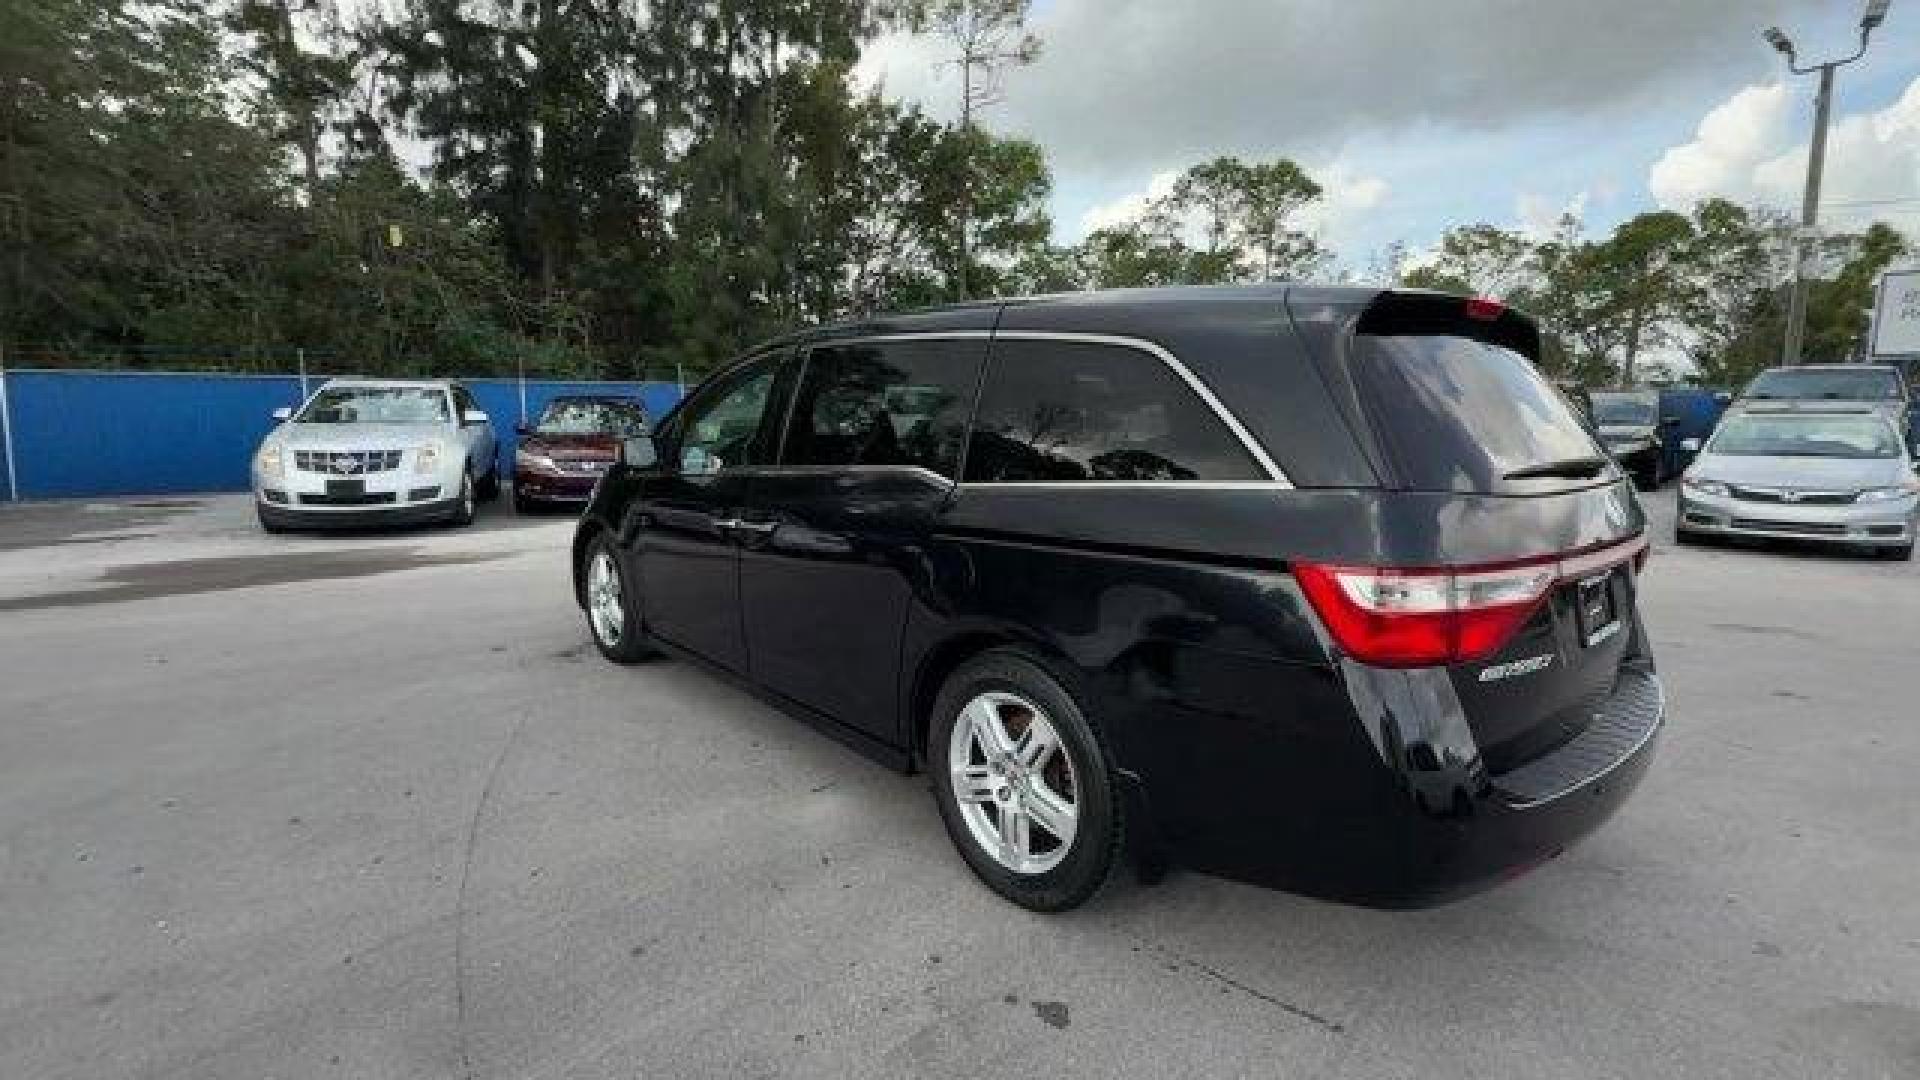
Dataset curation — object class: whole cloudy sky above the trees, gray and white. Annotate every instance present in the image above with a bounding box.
[862,0,1920,267]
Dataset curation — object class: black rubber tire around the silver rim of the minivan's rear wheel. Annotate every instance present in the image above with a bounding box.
[927,650,1125,911]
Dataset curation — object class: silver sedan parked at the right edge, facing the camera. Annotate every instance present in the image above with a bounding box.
[1674,405,1920,559]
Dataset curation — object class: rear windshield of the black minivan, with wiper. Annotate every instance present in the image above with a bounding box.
[1354,334,1613,492]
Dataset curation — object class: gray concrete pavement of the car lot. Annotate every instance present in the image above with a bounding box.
[0,494,1920,1080]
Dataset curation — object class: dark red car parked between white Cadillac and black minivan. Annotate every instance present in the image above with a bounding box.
[513,396,647,513]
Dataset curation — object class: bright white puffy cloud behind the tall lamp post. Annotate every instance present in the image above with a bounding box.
[1647,77,1920,227]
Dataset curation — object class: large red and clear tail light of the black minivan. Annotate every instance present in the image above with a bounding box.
[1294,536,1647,667]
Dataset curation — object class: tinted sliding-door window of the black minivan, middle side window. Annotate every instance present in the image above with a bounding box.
[780,340,987,480]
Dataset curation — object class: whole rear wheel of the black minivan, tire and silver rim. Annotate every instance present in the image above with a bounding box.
[927,650,1119,911]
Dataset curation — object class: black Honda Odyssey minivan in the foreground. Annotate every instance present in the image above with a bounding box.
[572,284,1665,911]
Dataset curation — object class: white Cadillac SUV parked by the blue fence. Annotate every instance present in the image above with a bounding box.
[253,379,499,532]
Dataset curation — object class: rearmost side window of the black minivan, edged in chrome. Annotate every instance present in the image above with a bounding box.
[966,340,1267,484]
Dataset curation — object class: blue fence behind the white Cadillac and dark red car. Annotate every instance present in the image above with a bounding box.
[0,371,680,500]
